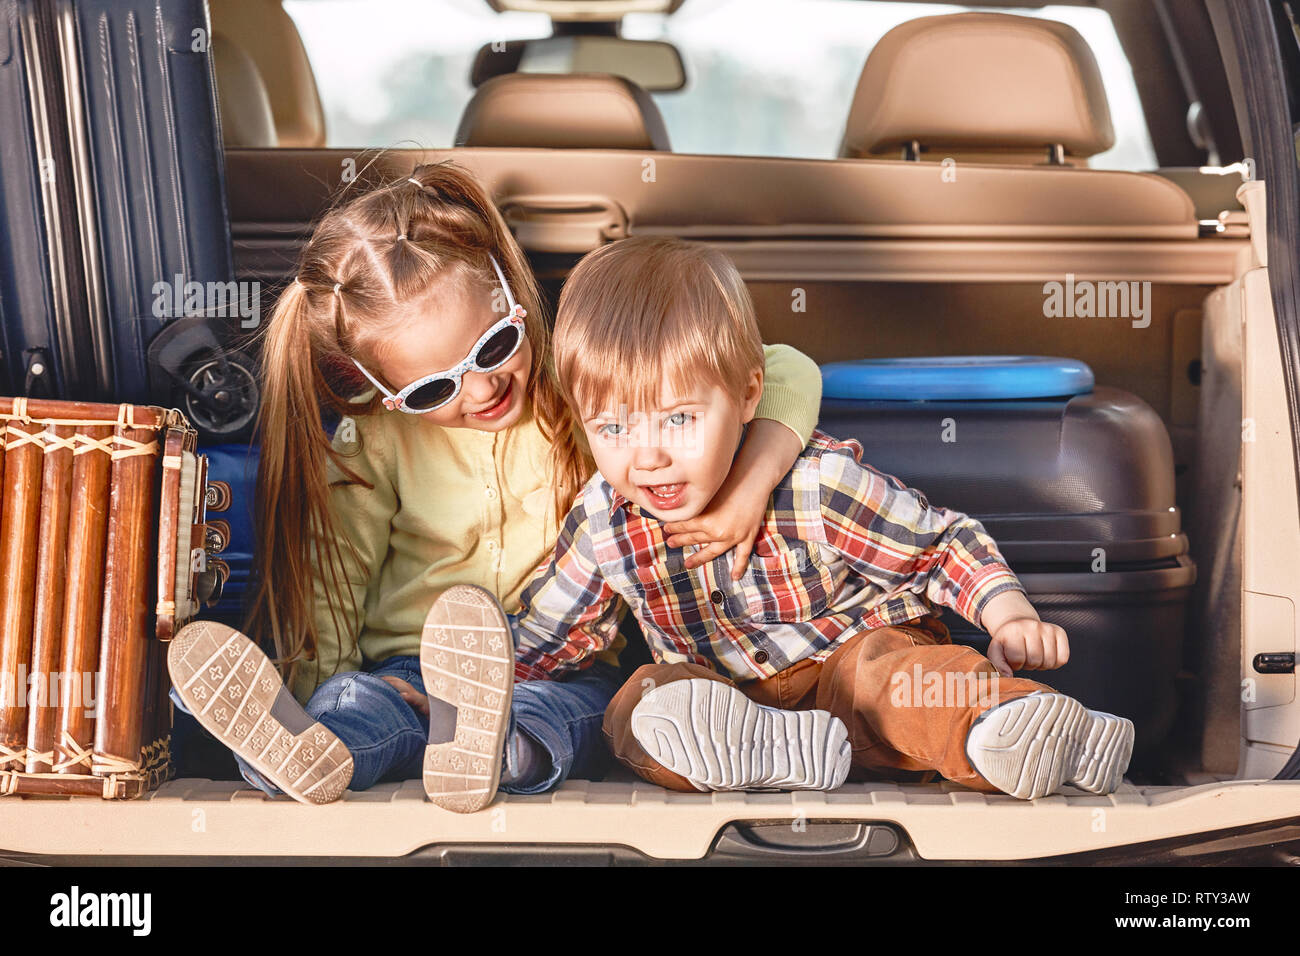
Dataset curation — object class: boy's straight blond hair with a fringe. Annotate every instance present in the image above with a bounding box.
[551,237,763,418]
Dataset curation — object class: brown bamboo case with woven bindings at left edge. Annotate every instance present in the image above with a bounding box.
[0,398,221,799]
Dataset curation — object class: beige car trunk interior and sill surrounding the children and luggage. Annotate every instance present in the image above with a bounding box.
[0,138,1300,862]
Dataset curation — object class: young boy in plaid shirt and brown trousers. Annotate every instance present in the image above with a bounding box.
[431,238,1134,799]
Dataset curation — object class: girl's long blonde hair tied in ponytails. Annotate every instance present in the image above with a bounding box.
[246,163,590,679]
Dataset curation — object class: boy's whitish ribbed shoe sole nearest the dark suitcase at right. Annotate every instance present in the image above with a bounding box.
[966,692,1134,800]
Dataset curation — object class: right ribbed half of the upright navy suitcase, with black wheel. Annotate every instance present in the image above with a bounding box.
[72,0,264,429]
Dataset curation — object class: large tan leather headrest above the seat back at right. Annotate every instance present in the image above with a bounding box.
[840,13,1115,161]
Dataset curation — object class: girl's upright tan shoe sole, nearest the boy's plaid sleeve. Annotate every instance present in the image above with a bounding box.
[420,584,515,813]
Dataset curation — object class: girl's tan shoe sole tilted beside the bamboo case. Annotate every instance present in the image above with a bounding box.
[166,620,352,804]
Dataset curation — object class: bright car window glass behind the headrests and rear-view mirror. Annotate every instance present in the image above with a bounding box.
[285,0,1156,169]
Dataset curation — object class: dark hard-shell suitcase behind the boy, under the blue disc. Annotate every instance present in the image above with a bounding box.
[819,388,1196,765]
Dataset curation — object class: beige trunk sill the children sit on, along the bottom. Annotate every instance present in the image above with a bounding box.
[0,778,1300,860]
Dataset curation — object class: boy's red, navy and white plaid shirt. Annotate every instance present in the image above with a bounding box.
[515,432,1023,682]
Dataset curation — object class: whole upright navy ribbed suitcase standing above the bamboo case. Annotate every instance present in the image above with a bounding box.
[0,0,261,441]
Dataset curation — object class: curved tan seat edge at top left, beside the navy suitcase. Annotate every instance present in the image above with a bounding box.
[208,0,325,150]
